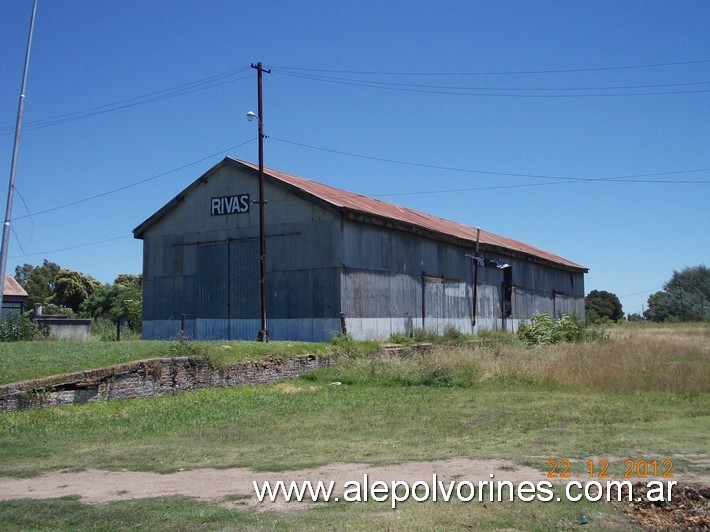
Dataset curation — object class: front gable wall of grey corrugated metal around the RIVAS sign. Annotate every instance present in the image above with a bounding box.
[144,164,342,340]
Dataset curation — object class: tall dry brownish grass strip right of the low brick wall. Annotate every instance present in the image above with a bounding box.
[318,326,710,394]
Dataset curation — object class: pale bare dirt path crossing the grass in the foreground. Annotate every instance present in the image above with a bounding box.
[0,458,545,510]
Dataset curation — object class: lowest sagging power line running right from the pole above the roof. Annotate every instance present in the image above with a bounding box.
[269,136,710,185]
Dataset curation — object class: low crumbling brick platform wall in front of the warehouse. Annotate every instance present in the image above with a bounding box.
[0,355,333,412]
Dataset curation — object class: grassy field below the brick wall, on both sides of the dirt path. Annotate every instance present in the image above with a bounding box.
[0,325,710,530]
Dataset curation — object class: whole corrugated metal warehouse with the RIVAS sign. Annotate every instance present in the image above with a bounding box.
[134,157,588,341]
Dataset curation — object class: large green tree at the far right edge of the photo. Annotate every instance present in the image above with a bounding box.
[644,264,710,321]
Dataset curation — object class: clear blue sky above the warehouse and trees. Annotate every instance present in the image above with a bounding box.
[0,0,710,313]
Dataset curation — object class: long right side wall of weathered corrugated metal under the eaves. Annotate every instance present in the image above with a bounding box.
[342,221,584,338]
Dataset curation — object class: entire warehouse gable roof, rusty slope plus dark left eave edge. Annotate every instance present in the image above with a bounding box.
[133,157,588,272]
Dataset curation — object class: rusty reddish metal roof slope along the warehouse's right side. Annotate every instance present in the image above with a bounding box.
[234,157,588,271]
